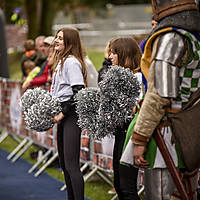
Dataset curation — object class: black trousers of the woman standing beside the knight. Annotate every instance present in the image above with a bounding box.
[113,132,140,200]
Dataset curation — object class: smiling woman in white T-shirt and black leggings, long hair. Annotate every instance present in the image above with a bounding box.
[51,28,87,200]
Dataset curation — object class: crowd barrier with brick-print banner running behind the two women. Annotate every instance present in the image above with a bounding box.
[0,78,143,198]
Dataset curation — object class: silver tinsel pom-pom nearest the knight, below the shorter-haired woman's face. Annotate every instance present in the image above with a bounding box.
[97,66,140,137]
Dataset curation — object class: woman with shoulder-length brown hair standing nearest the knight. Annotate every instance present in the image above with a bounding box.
[107,37,142,200]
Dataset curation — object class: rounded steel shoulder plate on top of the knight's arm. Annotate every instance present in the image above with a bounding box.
[154,32,186,65]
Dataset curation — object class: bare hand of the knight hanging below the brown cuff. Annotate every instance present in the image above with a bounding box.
[133,144,149,168]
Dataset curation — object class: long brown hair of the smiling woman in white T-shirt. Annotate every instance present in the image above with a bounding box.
[56,27,87,86]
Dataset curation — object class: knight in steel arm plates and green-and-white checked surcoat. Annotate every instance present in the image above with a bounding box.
[132,0,200,200]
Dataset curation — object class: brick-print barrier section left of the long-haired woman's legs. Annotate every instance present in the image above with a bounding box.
[0,78,57,177]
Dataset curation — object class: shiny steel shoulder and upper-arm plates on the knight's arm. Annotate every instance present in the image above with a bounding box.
[154,32,186,98]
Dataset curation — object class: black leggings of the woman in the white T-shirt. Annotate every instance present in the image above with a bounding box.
[57,108,84,200]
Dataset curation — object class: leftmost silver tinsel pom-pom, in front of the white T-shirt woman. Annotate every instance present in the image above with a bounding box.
[20,88,61,131]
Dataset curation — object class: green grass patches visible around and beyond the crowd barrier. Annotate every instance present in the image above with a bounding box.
[0,50,115,200]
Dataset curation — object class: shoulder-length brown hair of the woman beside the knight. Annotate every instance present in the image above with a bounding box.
[108,37,142,73]
